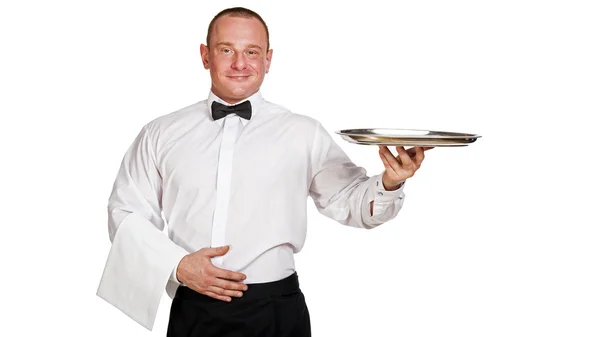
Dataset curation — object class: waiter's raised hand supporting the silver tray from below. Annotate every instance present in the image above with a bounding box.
[379,145,433,191]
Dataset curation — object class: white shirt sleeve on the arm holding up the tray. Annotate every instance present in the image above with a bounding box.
[309,122,405,229]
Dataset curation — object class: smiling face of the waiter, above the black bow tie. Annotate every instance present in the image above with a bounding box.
[200,15,273,103]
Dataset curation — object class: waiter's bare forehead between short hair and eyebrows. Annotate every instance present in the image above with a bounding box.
[211,15,267,48]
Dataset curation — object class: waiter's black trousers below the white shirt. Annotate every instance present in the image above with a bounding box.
[167,273,311,337]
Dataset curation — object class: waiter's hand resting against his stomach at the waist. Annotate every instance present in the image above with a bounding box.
[177,246,248,302]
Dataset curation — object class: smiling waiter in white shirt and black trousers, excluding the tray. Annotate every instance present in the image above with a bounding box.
[98,8,427,337]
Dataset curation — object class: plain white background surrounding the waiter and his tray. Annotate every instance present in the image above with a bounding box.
[0,0,600,337]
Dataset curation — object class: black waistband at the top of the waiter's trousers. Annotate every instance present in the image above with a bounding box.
[175,272,300,303]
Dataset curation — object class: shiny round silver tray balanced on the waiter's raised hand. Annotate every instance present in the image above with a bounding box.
[336,128,481,147]
